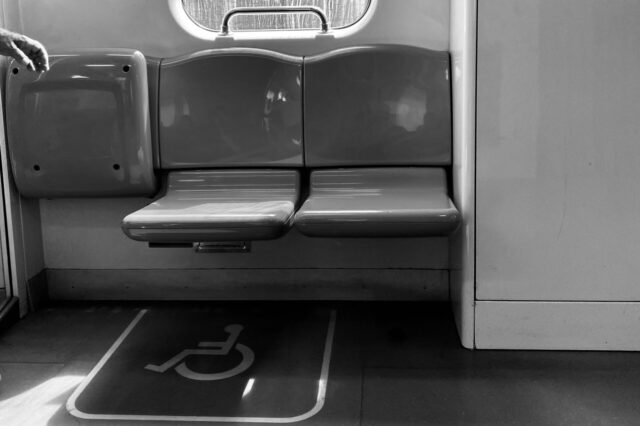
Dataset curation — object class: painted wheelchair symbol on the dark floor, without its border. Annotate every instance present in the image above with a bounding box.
[144,324,254,381]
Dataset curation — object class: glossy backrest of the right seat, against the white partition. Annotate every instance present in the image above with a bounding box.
[304,45,451,167]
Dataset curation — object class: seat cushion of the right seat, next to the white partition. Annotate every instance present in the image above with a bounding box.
[295,167,460,237]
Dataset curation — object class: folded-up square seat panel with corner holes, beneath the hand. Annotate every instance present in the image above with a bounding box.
[7,49,155,198]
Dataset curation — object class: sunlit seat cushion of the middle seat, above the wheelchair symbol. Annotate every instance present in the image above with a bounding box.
[122,170,300,244]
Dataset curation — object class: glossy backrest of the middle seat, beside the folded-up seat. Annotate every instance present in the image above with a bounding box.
[159,48,302,169]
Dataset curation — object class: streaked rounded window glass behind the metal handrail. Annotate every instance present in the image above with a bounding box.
[182,0,370,31]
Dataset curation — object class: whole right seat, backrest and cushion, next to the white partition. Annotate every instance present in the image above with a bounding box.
[295,45,460,237]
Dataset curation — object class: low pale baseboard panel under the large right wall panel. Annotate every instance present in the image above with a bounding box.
[476,302,640,351]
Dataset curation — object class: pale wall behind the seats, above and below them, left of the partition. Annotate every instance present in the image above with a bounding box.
[2,0,450,310]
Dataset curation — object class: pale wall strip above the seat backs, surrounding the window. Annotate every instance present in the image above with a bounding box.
[3,0,449,57]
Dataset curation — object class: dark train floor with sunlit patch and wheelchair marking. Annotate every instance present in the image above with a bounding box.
[0,302,640,426]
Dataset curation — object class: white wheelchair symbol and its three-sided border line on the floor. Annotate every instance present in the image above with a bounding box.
[66,309,336,423]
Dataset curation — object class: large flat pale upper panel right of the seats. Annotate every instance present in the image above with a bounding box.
[477,0,640,301]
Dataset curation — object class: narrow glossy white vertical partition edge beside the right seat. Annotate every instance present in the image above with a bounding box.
[451,0,477,348]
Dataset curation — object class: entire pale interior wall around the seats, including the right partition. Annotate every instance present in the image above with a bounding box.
[1,0,640,350]
